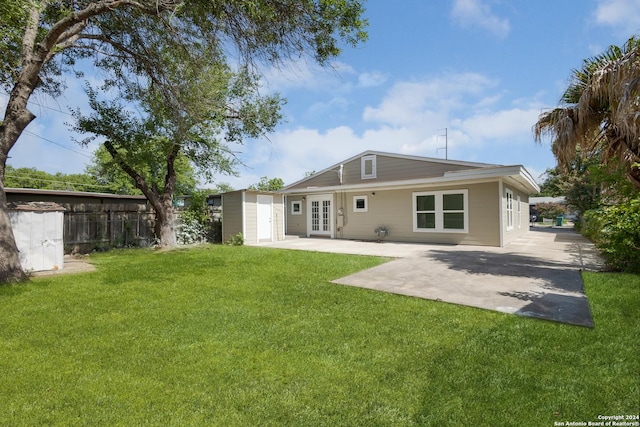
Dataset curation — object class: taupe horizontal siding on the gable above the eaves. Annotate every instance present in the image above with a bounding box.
[291,155,482,189]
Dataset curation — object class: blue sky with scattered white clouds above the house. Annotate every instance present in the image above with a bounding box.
[0,0,640,189]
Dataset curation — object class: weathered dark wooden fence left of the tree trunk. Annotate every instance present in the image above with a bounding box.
[63,205,155,253]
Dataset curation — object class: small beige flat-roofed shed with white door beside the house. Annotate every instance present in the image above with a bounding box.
[222,190,284,245]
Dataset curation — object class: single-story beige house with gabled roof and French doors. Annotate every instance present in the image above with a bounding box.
[280,151,539,246]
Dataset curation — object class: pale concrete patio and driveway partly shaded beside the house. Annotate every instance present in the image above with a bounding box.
[261,227,602,327]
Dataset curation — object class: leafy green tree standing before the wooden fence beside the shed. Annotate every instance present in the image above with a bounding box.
[74,56,281,247]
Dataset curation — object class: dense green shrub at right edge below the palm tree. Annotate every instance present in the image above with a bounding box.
[581,199,640,273]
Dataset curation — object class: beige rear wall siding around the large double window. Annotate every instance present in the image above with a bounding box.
[335,182,500,246]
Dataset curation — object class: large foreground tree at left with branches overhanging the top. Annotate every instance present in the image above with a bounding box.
[0,0,366,282]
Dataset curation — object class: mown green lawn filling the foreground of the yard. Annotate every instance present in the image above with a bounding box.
[0,246,640,426]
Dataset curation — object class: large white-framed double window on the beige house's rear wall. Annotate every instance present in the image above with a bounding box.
[413,190,469,233]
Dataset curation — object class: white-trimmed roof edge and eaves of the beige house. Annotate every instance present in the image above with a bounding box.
[280,151,540,194]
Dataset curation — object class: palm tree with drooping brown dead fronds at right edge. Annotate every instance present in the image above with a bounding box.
[533,36,640,190]
